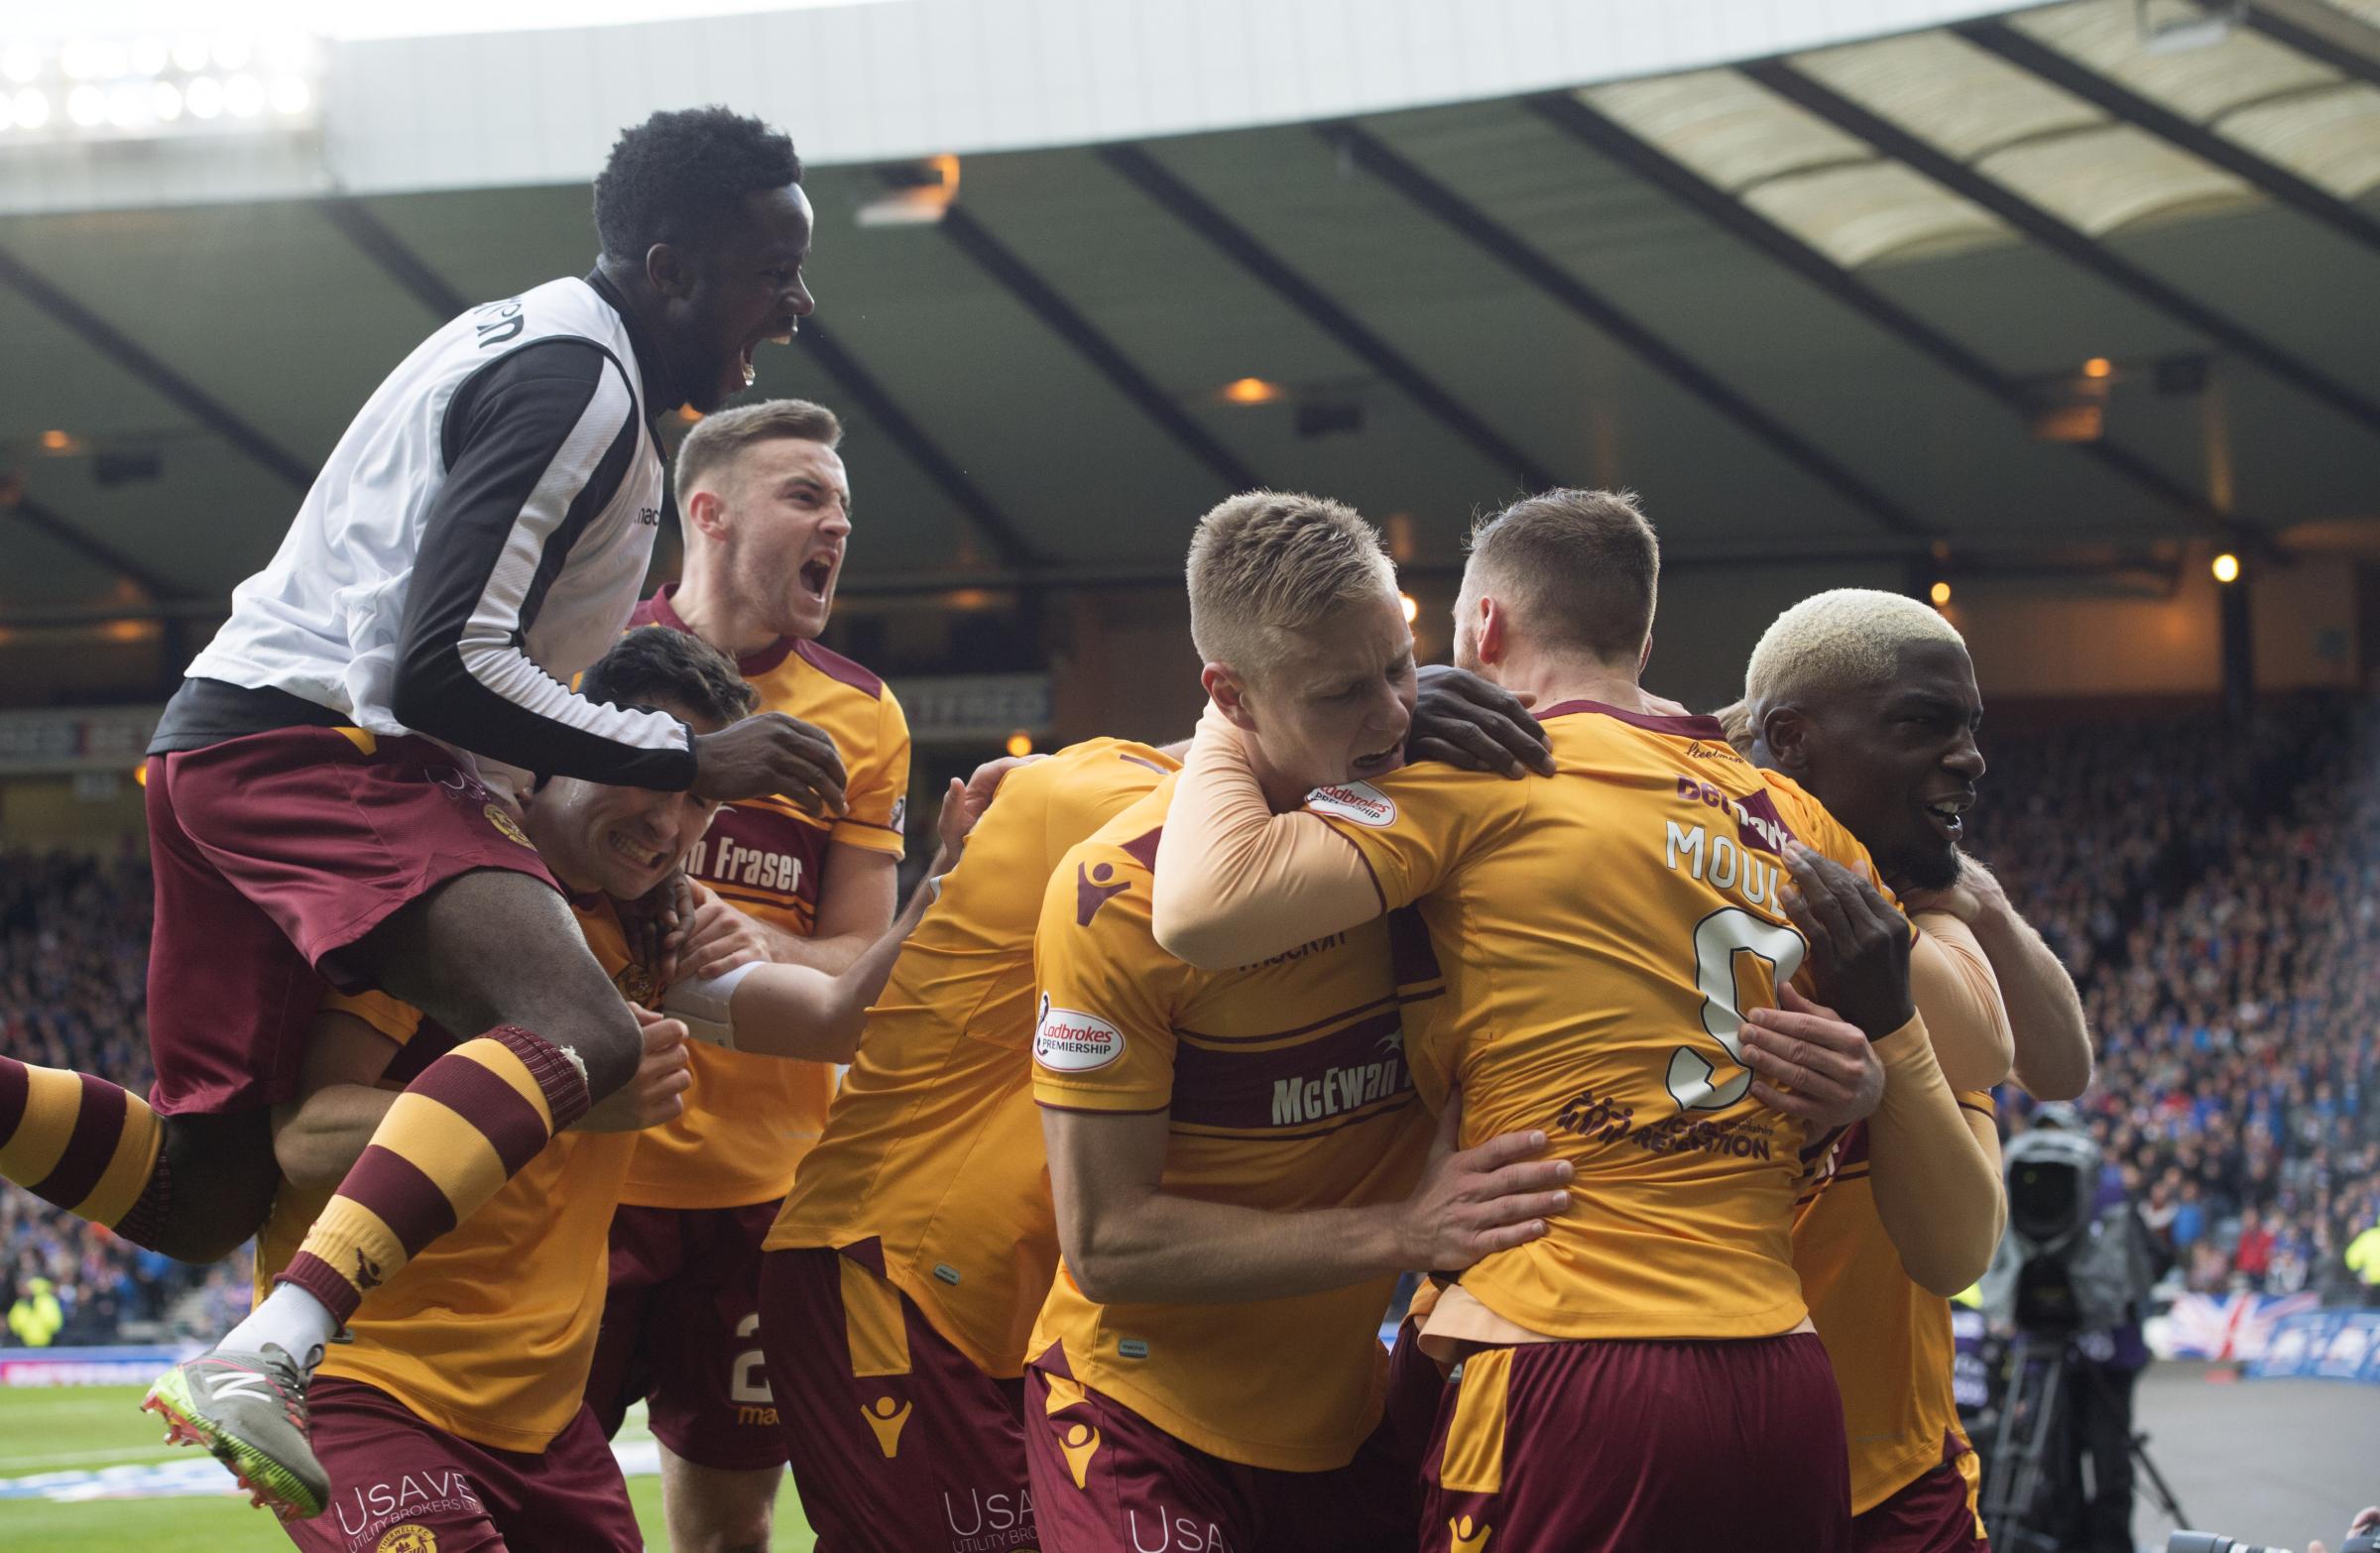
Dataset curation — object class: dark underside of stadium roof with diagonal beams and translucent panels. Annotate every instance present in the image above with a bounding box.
[0,0,2380,619]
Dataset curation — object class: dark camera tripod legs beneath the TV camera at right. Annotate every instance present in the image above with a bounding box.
[1980,1332,2190,1553]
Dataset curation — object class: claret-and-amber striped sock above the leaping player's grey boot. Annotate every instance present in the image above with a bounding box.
[276,1024,590,1324]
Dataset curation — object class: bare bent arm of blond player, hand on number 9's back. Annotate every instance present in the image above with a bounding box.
[1042,1103,1571,1305]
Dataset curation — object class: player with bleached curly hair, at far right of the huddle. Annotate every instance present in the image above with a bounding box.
[1727,588,2089,1553]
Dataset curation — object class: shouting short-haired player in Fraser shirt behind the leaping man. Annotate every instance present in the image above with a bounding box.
[588,401,909,1553]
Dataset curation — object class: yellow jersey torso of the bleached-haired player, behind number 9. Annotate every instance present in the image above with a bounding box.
[1792,1091,1992,1515]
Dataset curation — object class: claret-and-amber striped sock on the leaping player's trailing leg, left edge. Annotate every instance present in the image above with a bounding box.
[0,1057,165,1246]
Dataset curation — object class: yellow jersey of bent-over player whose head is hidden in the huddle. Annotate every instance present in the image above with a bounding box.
[767,739,1180,1376]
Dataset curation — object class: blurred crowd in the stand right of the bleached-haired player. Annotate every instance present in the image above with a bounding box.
[1977,698,2380,1296]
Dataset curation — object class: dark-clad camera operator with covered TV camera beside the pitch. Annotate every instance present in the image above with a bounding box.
[1982,1103,2161,1553]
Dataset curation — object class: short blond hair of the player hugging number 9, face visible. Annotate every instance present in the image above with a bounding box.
[1190,491,1397,679]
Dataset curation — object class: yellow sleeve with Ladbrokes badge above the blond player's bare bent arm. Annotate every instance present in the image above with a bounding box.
[1033,843,1185,1113]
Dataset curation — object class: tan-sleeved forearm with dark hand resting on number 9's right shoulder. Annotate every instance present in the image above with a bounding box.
[1785,843,2009,1298]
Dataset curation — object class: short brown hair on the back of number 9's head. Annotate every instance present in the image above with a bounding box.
[1457,488,1661,667]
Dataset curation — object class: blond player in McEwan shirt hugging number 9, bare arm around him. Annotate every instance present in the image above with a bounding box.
[1025,491,1569,1553]
